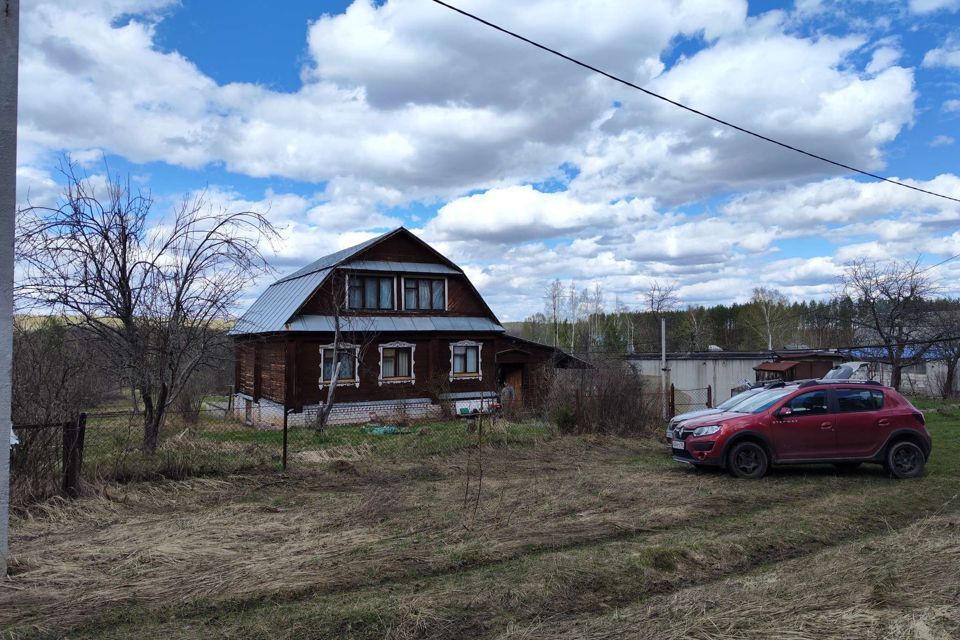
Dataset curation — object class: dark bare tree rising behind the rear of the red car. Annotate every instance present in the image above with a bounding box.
[841,260,937,390]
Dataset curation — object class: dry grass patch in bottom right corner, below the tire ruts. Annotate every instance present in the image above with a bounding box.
[516,516,960,640]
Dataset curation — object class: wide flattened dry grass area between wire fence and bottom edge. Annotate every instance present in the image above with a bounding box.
[0,430,958,638]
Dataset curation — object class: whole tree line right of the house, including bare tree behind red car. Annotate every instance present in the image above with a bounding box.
[508,260,960,390]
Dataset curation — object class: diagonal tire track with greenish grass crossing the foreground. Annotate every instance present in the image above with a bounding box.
[47,483,956,638]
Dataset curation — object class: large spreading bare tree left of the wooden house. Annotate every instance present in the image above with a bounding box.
[17,162,276,451]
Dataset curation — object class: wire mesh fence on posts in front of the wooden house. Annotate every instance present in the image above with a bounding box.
[11,397,555,507]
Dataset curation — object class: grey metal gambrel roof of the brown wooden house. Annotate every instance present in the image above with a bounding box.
[230,227,503,335]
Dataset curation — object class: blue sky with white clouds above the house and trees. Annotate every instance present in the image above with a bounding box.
[18,0,960,320]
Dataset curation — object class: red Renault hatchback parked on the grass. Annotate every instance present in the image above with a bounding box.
[671,380,932,478]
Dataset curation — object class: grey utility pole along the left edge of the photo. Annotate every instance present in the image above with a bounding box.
[0,0,20,578]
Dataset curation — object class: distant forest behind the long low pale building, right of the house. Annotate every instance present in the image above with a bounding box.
[505,281,960,355]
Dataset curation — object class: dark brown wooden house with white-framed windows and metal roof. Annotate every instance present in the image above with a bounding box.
[230,227,577,424]
